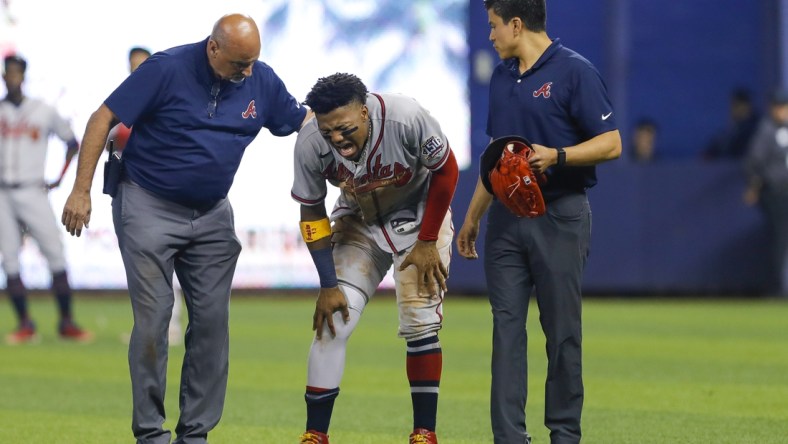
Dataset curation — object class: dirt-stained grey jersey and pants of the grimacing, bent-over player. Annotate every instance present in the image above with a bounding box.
[291,94,453,340]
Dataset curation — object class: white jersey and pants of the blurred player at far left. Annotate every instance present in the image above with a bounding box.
[0,97,74,275]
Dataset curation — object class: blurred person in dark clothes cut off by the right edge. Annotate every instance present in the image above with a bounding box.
[744,89,788,297]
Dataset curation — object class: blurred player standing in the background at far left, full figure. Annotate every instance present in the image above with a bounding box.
[0,55,93,344]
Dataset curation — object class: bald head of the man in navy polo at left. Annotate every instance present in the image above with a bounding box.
[206,14,260,83]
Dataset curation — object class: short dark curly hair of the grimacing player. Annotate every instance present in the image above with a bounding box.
[304,72,368,114]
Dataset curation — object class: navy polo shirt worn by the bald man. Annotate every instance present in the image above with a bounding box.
[104,39,306,208]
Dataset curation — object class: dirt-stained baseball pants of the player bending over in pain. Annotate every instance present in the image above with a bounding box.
[307,212,454,388]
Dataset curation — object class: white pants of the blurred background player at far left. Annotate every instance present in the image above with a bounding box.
[0,183,66,276]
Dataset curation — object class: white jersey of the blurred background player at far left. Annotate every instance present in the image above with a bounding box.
[0,97,74,185]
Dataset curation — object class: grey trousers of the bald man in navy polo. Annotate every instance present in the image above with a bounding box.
[112,182,241,444]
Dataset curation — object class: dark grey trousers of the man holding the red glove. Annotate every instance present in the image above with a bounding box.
[484,193,591,444]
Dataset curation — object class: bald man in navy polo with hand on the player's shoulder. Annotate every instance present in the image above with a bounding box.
[62,14,311,444]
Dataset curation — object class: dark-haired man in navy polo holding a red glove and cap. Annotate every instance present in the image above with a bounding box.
[457,0,621,444]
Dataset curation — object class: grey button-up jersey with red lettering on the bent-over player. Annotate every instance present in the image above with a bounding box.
[291,94,451,253]
